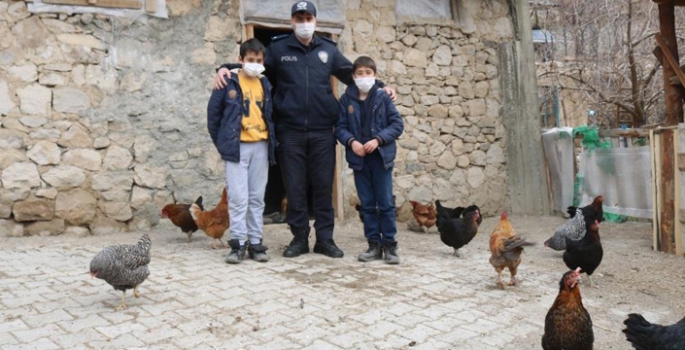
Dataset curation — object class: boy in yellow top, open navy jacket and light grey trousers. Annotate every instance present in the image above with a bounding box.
[207,39,276,264]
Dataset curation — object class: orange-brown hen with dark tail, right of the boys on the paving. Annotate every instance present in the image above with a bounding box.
[490,211,533,289]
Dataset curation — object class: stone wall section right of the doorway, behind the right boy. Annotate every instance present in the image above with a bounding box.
[340,0,512,221]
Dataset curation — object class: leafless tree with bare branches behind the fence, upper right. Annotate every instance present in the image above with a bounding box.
[536,0,685,127]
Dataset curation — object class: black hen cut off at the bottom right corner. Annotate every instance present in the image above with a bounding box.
[623,314,685,350]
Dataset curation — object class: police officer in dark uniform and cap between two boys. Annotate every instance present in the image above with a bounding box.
[215,1,395,258]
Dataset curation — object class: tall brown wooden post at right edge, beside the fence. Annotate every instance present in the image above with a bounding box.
[658,3,683,253]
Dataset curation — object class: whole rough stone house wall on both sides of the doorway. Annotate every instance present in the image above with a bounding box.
[0,0,511,236]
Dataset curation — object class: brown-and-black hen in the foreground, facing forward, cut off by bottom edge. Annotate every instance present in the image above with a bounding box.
[542,268,595,350]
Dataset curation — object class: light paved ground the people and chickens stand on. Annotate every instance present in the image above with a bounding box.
[0,217,685,350]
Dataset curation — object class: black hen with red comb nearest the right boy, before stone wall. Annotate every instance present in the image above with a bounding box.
[435,201,480,256]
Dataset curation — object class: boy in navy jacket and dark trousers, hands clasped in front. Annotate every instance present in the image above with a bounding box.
[336,56,404,264]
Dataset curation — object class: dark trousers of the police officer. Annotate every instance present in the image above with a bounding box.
[277,127,336,240]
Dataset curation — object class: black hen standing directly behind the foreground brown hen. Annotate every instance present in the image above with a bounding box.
[564,220,604,285]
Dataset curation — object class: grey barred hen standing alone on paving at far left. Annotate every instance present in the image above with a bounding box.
[90,234,152,311]
